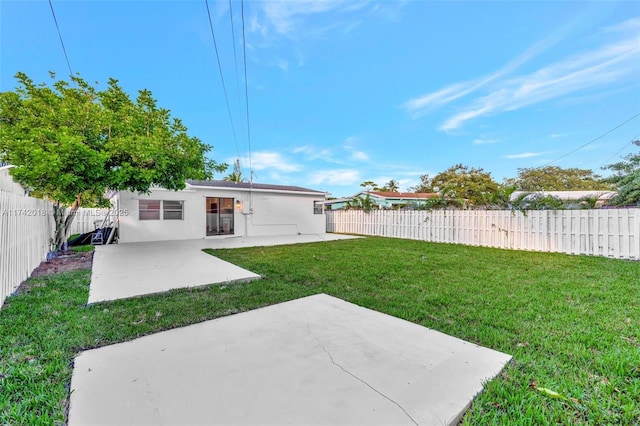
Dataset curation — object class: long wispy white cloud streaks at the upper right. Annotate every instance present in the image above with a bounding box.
[404,19,640,131]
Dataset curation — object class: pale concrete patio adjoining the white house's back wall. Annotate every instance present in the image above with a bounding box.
[88,234,355,303]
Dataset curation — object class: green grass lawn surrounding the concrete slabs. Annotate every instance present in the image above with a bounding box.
[0,238,640,425]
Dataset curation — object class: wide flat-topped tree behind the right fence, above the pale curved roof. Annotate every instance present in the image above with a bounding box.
[505,166,611,192]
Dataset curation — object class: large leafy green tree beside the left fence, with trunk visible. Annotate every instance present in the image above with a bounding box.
[0,73,227,249]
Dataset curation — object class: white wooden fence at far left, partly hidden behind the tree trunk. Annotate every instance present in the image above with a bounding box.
[0,191,108,307]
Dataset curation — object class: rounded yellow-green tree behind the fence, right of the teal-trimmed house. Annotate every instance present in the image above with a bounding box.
[423,164,498,206]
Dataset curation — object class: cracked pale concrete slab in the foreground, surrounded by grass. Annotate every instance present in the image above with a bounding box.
[68,294,511,426]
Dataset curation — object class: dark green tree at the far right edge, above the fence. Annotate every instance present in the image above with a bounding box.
[604,140,640,206]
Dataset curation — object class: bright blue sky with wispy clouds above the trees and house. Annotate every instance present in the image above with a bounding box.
[0,0,640,197]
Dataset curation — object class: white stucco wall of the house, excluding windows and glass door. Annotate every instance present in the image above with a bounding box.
[118,188,326,243]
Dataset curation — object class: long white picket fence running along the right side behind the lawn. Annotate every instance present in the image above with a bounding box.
[327,208,640,260]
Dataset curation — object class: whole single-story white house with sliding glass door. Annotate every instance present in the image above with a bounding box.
[117,181,326,243]
